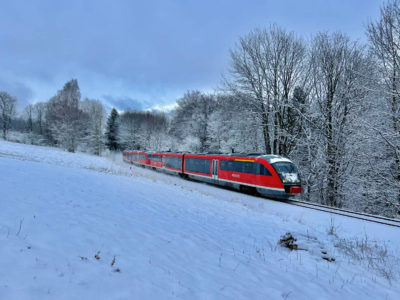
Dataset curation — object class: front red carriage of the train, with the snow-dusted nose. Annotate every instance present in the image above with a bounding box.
[184,154,301,198]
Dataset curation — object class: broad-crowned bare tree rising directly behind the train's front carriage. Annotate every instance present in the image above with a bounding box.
[225,26,307,155]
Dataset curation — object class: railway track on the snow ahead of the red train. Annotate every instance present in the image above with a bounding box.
[285,199,400,228]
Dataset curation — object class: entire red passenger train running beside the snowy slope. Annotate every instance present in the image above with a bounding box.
[123,150,301,199]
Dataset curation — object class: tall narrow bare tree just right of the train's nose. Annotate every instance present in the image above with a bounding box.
[311,33,367,206]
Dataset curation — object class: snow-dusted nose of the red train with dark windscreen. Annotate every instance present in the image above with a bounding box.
[262,155,302,199]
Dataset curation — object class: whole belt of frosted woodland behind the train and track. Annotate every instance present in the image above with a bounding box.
[0,1,400,217]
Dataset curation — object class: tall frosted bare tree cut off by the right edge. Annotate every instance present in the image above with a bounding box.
[367,0,400,214]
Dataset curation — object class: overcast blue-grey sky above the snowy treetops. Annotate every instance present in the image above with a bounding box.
[0,0,383,110]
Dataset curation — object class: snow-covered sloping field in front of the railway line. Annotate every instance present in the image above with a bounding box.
[0,142,400,300]
